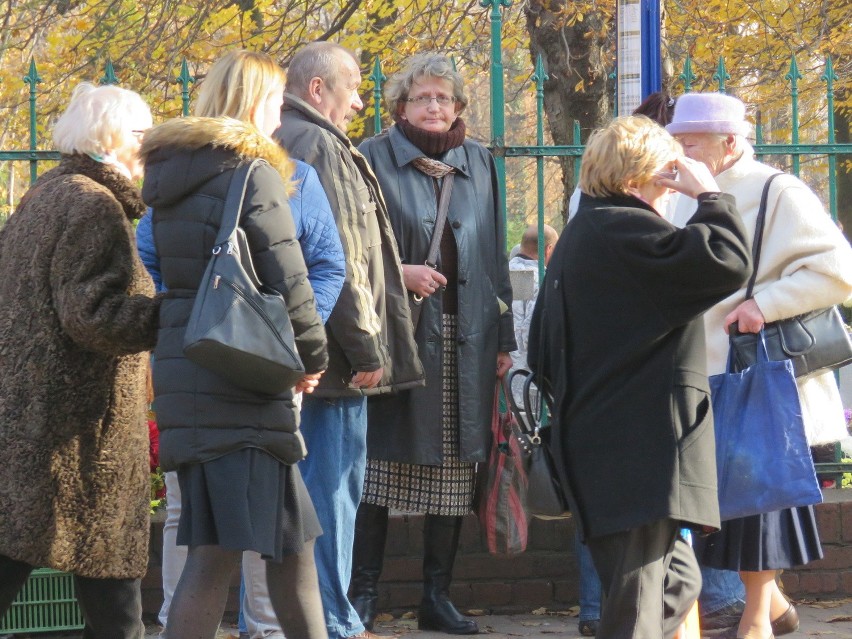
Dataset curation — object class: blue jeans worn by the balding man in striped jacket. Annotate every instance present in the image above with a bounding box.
[299,395,367,639]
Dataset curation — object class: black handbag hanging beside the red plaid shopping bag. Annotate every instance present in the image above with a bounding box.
[506,369,568,519]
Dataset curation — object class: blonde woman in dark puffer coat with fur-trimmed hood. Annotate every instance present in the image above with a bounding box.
[142,50,328,639]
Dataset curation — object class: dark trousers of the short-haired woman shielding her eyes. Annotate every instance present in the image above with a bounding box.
[586,519,701,639]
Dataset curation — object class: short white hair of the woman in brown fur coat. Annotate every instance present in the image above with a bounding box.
[53,82,153,156]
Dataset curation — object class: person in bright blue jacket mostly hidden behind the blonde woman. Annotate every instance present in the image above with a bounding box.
[136,155,346,639]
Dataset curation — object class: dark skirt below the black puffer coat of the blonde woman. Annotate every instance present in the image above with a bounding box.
[177,448,322,562]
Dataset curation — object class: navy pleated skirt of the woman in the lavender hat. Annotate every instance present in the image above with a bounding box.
[694,506,822,572]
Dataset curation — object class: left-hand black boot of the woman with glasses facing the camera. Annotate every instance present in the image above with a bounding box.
[349,502,388,630]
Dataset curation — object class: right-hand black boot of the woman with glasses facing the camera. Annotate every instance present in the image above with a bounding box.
[417,515,479,635]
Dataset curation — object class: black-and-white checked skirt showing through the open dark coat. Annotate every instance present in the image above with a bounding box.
[362,315,476,517]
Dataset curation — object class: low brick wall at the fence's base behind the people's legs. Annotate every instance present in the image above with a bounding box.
[142,490,852,616]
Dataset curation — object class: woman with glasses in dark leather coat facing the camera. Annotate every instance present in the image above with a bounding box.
[351,54,515,634]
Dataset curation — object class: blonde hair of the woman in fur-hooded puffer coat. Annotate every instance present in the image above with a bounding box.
[194,50,284,122]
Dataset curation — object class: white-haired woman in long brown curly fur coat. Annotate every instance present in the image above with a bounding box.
[0,84,159,639]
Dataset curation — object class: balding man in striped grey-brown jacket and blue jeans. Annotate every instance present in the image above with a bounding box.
[275,42,423,639]
